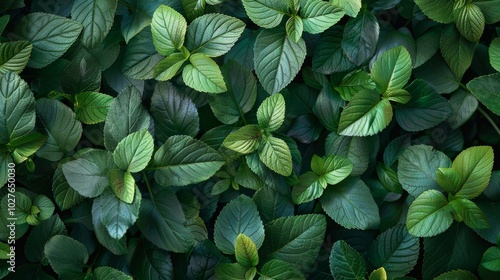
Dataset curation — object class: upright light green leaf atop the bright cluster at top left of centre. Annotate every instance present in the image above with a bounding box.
[151,5,187,56]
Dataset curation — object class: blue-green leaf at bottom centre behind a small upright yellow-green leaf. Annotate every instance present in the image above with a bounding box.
[214,195,264,254]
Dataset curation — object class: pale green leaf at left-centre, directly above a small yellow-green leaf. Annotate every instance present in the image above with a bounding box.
[113,129,154,172]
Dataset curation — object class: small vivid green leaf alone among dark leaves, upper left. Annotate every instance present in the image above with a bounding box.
[75,92,114,124]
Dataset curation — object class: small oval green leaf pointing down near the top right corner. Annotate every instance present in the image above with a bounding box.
[453,2,485,42]
